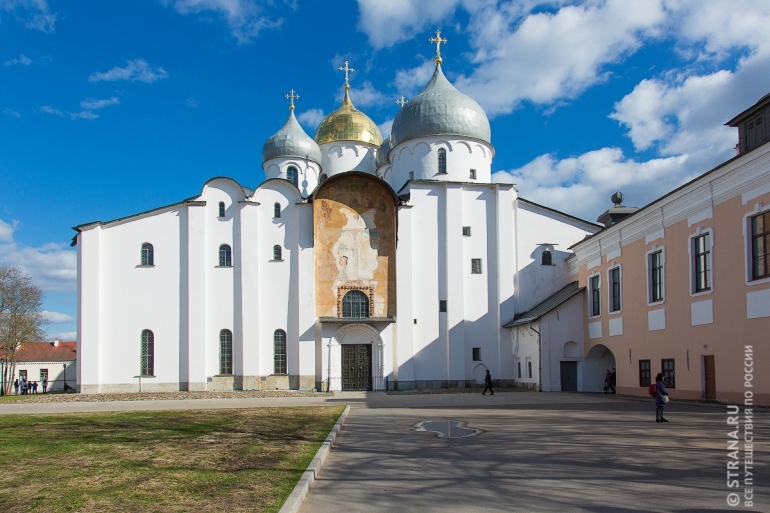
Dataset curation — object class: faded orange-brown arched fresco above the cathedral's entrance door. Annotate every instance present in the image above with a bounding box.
[313,176,396,317]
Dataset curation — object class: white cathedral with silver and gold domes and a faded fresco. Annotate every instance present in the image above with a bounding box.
[75,45,599,393]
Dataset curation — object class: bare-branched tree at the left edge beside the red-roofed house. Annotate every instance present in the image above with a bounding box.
[0,265,46,394]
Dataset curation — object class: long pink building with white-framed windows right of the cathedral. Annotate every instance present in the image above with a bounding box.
[568,95,770,405]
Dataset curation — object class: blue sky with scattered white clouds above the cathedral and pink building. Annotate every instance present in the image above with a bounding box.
[0,0,770,339]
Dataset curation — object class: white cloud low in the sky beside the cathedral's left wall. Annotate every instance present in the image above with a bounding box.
[0,219,77,293]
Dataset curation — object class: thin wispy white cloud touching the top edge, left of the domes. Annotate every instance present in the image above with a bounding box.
[161,0,282,44]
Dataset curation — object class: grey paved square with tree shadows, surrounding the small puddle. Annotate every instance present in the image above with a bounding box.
[300,393,770,513]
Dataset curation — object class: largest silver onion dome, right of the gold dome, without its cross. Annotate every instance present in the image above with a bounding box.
[391,64,492,146]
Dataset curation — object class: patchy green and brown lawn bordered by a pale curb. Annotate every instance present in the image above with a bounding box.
[0,407,343,513]
